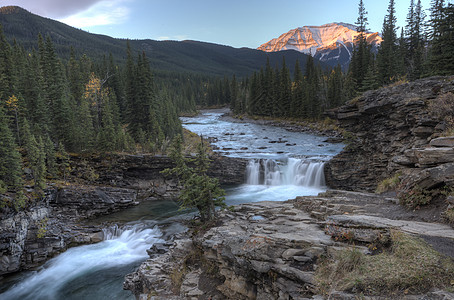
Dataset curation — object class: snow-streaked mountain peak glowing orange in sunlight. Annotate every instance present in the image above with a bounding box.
[258,23,382,68]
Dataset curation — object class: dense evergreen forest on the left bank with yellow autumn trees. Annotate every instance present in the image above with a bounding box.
[0,27,184,208]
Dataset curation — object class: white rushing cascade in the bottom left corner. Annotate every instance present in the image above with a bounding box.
[0,224,163,300]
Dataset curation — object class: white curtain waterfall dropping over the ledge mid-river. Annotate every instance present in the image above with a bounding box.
[246,158,325,188]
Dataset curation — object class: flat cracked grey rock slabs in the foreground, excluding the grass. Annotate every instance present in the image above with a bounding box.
[124,191,454,300]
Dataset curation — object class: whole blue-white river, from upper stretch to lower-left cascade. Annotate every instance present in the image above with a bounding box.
[0,110,343,300]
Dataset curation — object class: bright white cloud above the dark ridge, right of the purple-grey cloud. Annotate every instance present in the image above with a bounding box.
[59,0,130,28]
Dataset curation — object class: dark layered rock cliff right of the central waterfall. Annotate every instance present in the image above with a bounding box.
[325,77,454,191]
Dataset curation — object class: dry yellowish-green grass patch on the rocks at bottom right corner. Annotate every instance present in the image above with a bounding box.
[315,231,454,295]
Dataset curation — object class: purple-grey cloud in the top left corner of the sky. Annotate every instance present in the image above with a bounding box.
[0,0,103,18]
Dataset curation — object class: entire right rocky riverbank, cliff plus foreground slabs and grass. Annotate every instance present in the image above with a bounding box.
[124,77,454,299]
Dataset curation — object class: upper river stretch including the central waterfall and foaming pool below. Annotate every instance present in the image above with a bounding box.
[182,110,343,205]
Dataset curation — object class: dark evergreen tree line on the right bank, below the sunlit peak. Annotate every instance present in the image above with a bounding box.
[225,0,454,120]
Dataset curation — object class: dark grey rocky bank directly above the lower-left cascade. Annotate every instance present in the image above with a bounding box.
[0,186,136,275]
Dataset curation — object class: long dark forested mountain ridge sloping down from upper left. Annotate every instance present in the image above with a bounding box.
[0,6,326,77]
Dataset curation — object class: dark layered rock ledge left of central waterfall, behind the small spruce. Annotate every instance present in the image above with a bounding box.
[72,154,247,200]
